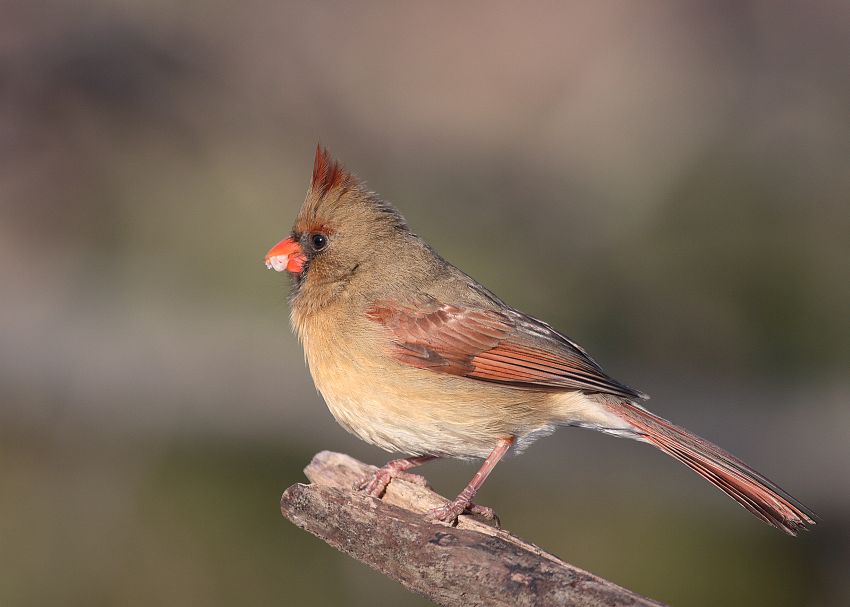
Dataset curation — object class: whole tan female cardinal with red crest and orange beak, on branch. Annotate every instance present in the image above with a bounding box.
[265,148,814,535]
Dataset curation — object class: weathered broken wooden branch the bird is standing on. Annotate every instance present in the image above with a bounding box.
[280,451,661,607]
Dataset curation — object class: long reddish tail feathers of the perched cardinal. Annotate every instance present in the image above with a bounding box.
[606,400,815,535]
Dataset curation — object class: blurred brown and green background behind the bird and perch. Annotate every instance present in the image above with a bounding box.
[0,0,850,606]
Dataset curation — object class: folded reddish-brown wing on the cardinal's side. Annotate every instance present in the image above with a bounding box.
[368,302,643,398]
